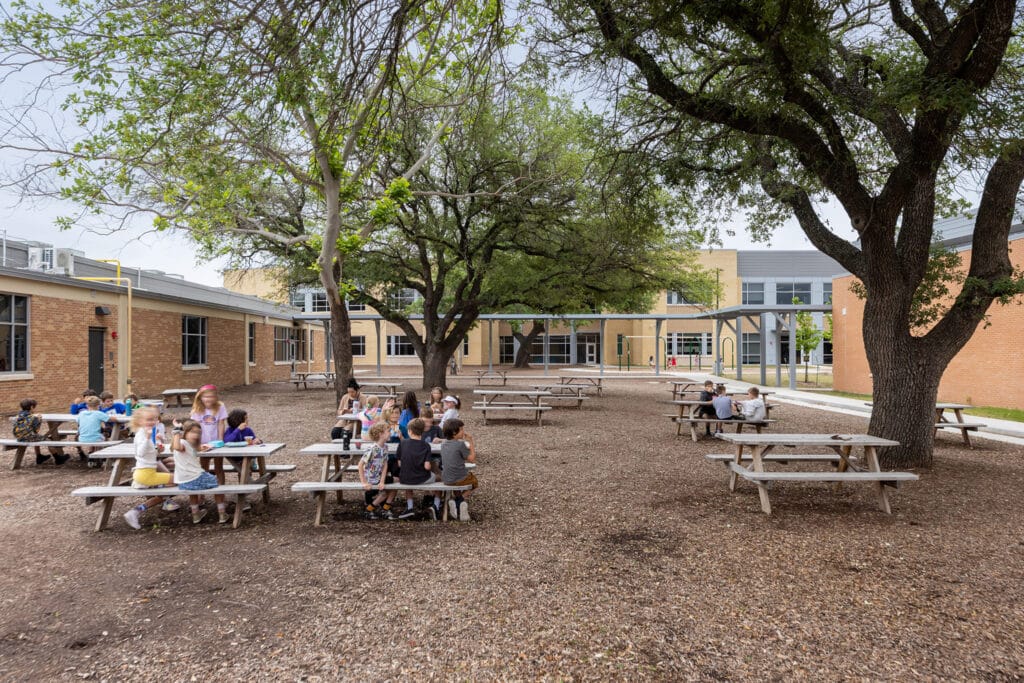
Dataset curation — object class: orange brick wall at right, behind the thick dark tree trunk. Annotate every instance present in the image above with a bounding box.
[833,240,1024,408]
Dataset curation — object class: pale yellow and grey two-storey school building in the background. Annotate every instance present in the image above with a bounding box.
[224,249,844,371]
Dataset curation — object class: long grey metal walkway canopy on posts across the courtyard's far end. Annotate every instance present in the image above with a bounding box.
[294,304,831,389]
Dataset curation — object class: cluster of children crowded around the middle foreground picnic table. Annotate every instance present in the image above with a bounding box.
[331,379,478,521]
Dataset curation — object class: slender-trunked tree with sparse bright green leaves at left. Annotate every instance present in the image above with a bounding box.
[0,0,503,403]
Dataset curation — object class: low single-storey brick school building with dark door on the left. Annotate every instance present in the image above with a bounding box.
[0,240,325,413]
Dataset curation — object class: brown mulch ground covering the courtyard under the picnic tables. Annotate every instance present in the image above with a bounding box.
[0,380,1024,681]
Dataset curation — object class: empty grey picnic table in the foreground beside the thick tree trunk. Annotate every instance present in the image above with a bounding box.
[706,434,918,514]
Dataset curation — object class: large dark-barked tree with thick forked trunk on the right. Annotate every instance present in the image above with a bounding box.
[554,0,1024,467]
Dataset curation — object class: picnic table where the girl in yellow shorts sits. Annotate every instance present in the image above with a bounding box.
[80,442,286,531]
